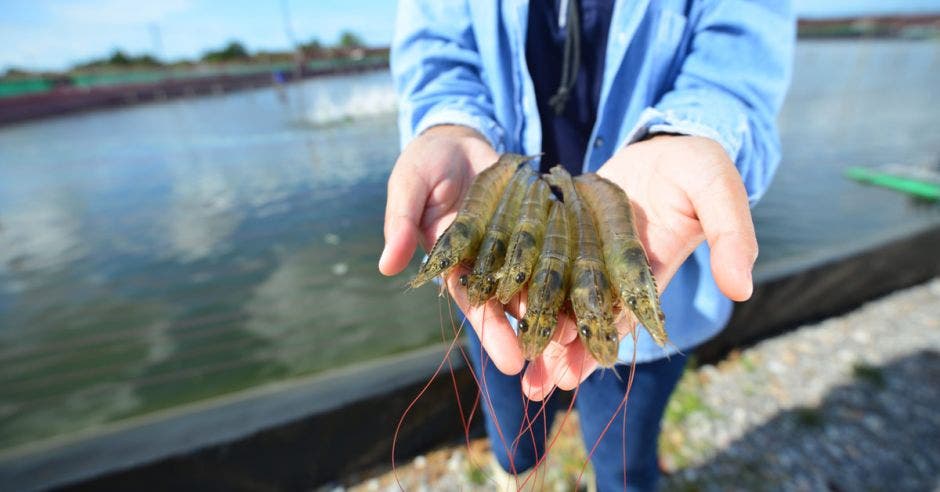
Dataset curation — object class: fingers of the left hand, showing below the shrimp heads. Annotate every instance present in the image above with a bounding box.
[447,269,525,376]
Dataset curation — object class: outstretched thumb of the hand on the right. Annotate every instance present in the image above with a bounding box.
[690,163,757,301]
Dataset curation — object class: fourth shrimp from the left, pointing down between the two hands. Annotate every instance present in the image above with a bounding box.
[519,198,572,360]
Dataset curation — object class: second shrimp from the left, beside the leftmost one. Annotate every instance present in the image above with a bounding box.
[460,166,536,306]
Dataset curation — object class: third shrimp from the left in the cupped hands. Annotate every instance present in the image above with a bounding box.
[496,173,552,304]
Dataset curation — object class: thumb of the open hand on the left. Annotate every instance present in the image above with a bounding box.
[379,162,428,275]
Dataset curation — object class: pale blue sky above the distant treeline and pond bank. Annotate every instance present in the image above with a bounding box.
[0,0,940,70]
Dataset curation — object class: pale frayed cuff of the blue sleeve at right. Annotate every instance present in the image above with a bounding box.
[621,107,746,162]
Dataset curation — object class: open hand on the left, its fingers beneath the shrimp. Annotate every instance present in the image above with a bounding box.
[379,126,524,374]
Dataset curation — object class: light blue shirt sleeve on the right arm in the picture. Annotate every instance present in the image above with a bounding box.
[627,0,796,205]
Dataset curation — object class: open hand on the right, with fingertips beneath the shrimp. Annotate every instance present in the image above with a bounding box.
[523,135,757,400]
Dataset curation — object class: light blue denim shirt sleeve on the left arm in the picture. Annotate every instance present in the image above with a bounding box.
[391,0,504,151]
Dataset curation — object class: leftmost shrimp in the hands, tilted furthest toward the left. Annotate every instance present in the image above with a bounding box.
[409,154,532,288]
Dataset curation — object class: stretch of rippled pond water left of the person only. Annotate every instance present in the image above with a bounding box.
[0,73,439,448]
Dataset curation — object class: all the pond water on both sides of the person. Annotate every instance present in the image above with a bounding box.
[0,42,940,448]
